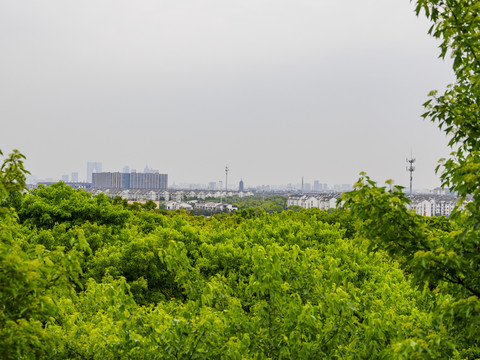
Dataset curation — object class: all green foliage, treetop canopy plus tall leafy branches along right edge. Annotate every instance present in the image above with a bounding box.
[0,0,480,359]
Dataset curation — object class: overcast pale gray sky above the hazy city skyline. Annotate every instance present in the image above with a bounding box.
[0,0,453,188]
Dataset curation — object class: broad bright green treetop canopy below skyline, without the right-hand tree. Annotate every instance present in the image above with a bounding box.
[0,171,461,359]
